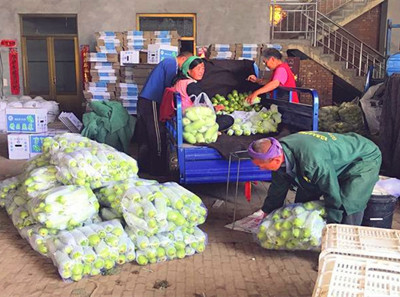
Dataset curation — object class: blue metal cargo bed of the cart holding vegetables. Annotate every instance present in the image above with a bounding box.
[166,87,319,184]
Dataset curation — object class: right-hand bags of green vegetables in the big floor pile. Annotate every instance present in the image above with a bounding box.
[97,180,207,265]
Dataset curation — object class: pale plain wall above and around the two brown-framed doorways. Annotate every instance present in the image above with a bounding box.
[0,0,270,94]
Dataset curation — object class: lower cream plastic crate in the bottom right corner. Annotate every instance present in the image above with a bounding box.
[312,255,400,297]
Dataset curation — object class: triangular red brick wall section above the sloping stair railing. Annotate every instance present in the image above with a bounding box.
[344,5,382,50]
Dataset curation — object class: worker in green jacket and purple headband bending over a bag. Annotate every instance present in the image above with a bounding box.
[248,131,382,225]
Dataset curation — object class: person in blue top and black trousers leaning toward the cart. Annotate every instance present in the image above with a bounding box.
[136,52,193,176]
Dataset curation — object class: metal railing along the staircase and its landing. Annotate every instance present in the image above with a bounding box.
[271,2,385,78]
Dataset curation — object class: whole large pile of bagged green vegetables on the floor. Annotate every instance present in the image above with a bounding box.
[0,133,207,281]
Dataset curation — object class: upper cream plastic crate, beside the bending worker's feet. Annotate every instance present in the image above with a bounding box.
[319,224,400,262]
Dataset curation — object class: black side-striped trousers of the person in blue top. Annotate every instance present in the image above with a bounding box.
[136,97,167,176]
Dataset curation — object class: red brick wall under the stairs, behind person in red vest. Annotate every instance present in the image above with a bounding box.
[297,60,333,106]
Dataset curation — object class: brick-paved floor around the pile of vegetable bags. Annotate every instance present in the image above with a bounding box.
[0,135,400,297]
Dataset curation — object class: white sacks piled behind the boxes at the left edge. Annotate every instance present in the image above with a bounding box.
[0,96,60,131]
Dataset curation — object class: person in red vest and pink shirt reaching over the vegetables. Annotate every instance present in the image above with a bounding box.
[246,48,299,104]
